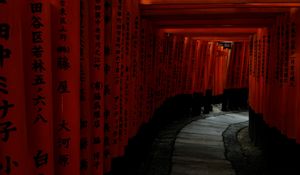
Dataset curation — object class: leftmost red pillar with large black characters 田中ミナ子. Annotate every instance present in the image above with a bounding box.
[0,0,28,175]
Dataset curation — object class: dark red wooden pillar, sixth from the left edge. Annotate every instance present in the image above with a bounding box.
[104,0,123,173]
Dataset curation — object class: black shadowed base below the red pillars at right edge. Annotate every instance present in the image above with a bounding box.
[249,109,300,175]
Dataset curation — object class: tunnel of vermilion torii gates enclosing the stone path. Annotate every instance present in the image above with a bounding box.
[0,0,300,175]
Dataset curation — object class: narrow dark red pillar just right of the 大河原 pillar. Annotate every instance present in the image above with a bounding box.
[80,0,93,175]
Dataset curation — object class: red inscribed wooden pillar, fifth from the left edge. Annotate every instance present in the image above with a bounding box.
[90,0,105,175]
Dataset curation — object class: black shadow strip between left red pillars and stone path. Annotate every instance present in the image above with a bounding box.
[107,94,198,175]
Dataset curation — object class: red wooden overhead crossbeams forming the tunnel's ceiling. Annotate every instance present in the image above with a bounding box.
[140,0,300,38]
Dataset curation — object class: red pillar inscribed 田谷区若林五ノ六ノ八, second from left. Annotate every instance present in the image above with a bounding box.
[24,0,53,175]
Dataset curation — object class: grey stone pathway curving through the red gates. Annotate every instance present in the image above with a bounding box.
[171,108,248,175]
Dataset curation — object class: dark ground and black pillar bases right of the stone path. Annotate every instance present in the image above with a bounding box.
[223,109,300,175]
